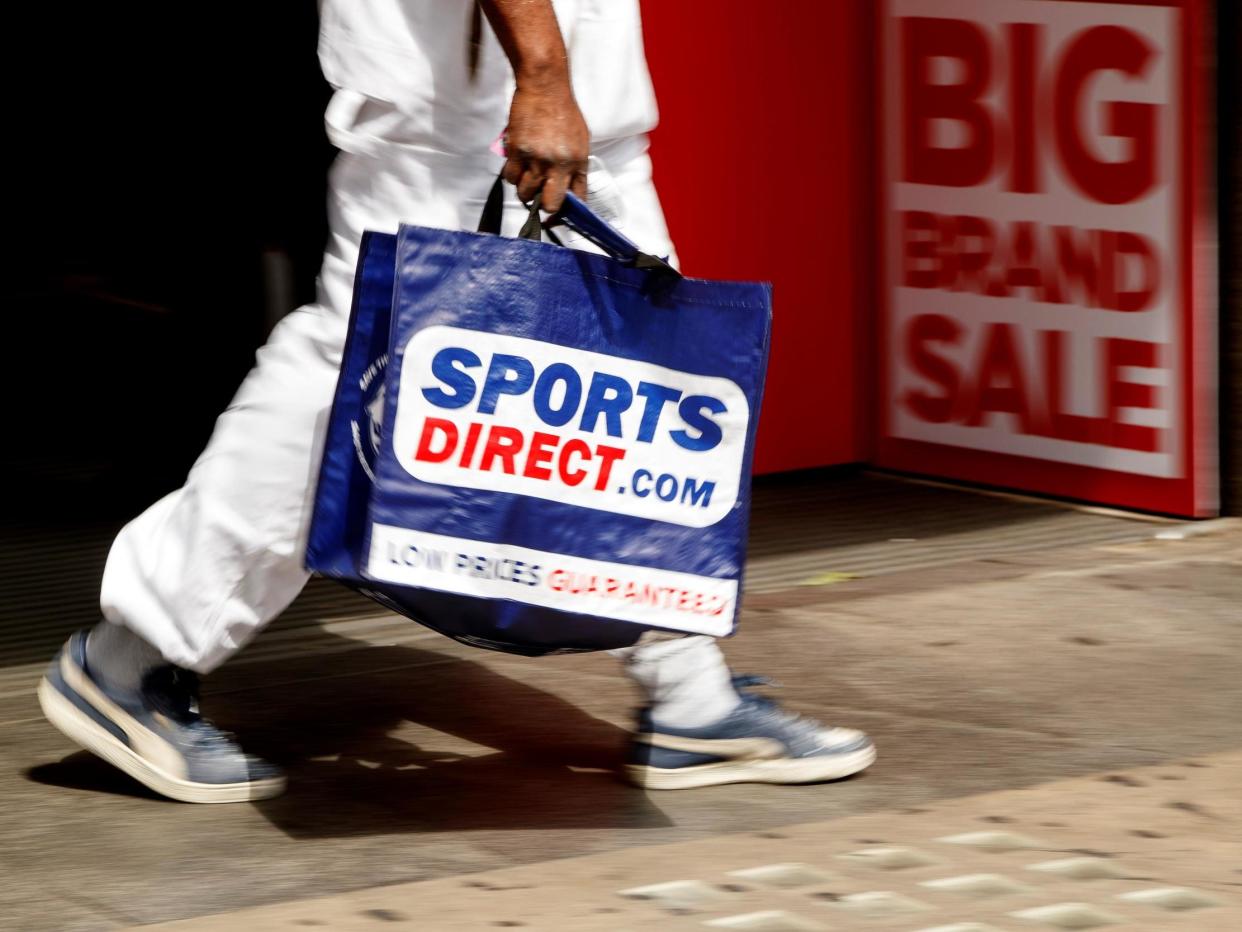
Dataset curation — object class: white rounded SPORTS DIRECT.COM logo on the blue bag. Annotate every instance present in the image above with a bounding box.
[392,327,750,527]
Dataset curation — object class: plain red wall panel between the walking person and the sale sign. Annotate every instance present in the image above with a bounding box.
[642,0,873,472]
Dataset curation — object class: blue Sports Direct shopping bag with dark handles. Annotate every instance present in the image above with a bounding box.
[306,178,771,655]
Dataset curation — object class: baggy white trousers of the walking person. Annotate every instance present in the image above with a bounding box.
[101,137,732,721]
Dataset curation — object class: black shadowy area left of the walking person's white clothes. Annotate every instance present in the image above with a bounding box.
[0,0,332,517]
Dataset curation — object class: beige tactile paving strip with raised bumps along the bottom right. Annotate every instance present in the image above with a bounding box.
[138,753,1242,932]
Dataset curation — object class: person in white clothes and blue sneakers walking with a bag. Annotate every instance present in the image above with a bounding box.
[39,0,876,803]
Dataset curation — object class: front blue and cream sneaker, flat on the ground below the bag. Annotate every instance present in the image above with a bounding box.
[626,676,876,789]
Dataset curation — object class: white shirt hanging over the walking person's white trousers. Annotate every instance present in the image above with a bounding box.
[319,0,657,154]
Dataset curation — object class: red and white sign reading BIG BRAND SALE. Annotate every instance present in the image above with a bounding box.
[879,0,1217,514]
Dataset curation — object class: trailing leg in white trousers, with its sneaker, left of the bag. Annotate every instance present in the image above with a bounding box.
[39,146,491,802]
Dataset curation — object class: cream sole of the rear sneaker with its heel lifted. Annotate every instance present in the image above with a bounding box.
[39,677,284,803]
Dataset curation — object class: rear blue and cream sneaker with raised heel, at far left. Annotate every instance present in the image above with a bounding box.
[39,631,284,803]
